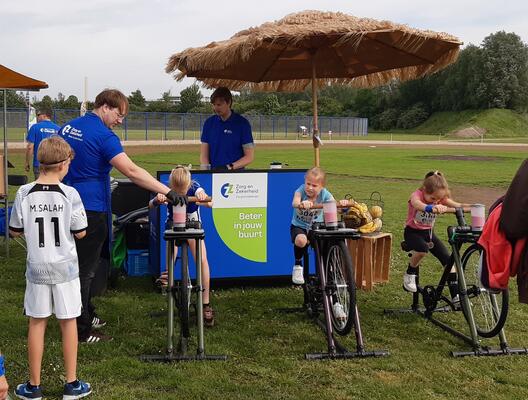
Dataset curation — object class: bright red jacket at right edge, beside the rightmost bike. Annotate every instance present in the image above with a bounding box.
[478,203,526,289]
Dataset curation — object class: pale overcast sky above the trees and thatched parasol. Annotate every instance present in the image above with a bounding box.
[0,0,528,100]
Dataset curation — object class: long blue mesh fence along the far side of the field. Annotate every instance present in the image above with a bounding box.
[0,109,368,141]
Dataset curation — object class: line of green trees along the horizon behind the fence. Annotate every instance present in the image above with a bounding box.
[0,31,528,130]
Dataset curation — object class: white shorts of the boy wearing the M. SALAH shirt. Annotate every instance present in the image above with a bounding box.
[24,278,82,319]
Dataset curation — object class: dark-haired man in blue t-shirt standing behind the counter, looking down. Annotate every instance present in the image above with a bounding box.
[200,87,255,170]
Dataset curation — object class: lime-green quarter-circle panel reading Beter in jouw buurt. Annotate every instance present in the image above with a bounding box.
[213,207,267,262]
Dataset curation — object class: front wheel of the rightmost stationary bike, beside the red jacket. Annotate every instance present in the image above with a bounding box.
[462,244,509,338]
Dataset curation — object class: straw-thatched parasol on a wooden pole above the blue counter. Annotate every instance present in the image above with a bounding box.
[165,11,462,165]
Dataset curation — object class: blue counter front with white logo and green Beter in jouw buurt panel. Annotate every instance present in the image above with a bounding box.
[150,169,306,278]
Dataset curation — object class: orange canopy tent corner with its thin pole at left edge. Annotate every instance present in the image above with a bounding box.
[0,64,48,254]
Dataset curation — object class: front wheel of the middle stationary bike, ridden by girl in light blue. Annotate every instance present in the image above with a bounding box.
[325,240,356,336]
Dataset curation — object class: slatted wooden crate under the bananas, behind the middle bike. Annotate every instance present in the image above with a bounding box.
[348,232,392,290]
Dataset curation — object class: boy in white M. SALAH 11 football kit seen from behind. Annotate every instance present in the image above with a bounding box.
[9,136,92,399]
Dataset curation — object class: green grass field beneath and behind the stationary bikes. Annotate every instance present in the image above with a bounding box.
[0,146,528,400]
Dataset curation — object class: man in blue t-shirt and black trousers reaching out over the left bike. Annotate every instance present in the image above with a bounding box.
[60,89,186,343]
